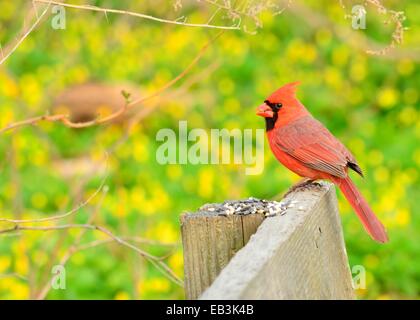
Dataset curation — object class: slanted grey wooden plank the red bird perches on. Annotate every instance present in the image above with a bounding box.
[201,184,354,299]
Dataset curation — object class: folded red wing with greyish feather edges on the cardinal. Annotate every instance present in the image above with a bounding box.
[274,116,361,178]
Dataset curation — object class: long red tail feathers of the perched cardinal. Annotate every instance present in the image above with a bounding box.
[334,177,388,243]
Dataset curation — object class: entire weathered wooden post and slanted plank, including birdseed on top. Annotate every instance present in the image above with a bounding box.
[181,183,354,299]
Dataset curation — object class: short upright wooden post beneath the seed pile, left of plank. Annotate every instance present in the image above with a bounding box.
[181,212,264,299]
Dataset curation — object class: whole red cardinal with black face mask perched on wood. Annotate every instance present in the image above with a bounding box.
[257,82,388,242]
